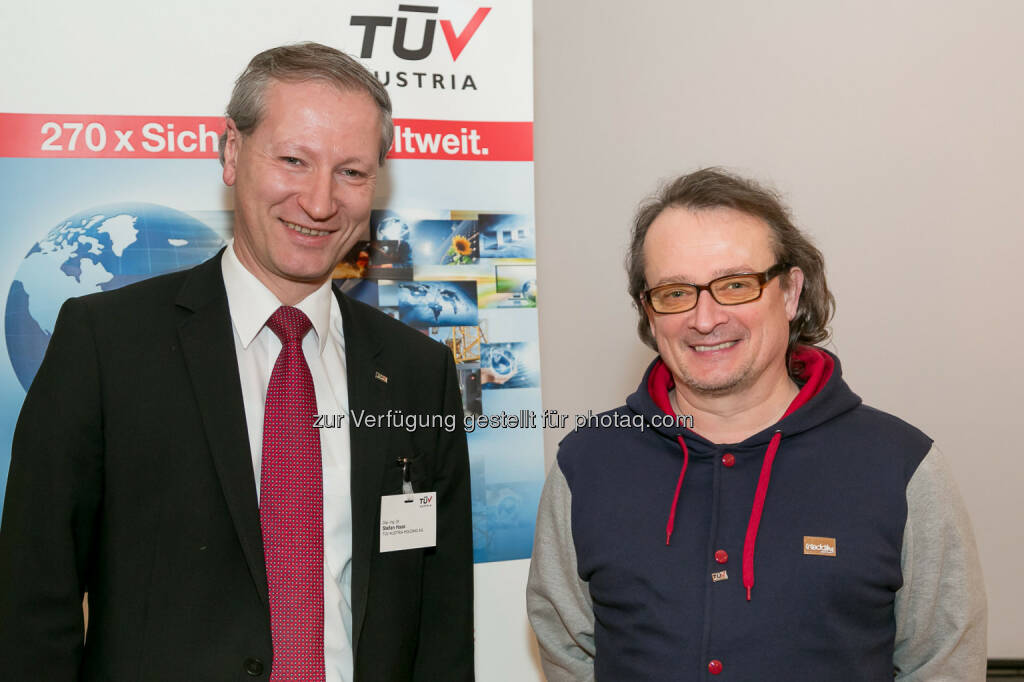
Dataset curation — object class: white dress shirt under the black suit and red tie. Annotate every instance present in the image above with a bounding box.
[220,242,352,682]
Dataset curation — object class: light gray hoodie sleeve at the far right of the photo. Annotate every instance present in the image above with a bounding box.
[893,446,987,682]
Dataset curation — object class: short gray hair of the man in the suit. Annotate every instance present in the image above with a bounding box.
[220,42,394,166]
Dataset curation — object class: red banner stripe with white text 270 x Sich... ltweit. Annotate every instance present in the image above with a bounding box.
[0,114,534,161]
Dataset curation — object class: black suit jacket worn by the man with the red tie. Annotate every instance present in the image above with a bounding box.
[0,251,473,682]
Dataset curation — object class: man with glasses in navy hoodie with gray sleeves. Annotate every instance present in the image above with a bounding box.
[526,169,986,682]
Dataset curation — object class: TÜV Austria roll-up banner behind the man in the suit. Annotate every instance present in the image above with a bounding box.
[0,0,544,679]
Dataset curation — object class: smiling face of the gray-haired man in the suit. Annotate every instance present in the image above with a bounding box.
[223,80,381,304]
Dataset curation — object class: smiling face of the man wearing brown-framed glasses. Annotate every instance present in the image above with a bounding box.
[643,207,803,396]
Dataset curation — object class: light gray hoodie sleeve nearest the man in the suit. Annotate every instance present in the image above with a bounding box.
[526,463,595,682]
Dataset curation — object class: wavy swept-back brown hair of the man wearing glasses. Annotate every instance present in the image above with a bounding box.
[626,168,836,371]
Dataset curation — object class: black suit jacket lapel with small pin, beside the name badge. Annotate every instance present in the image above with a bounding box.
[335,282,391,652]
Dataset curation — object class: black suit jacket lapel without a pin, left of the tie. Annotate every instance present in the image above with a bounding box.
[175,251,268,603]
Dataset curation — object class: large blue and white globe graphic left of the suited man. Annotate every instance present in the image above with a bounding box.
[4,203,224,390]
